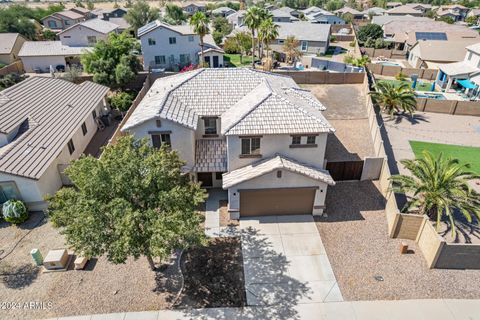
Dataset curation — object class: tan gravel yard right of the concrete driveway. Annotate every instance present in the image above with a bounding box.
[317,181,480,300]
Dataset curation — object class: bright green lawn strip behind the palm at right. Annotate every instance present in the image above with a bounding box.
[410,141,480,174]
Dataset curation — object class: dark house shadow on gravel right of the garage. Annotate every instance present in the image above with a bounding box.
[316,180,385,222]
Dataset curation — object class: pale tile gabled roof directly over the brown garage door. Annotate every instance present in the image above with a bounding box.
[222,154,335,189]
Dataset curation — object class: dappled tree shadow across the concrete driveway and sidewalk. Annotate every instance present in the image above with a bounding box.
[178,227,311,320]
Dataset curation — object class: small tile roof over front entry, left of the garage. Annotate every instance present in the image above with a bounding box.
[193,139,227,172]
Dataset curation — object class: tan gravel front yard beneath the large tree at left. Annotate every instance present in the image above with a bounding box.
[0,213,179,319]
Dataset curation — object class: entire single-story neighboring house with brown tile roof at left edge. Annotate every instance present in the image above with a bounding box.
[0,77,109,210]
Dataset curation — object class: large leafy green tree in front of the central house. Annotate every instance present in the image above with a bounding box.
[48,136,206,270]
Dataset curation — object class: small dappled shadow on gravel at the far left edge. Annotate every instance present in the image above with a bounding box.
[0,263,40,289]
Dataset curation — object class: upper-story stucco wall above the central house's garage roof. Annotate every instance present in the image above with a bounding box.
[227,133,328,171]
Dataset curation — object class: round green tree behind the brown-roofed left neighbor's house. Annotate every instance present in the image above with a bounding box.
[82,32,141,87]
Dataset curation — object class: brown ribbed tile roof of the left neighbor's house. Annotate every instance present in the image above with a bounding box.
[0,77,109,179]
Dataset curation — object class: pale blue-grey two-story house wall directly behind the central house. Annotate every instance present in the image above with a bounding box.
[140,27,200,70]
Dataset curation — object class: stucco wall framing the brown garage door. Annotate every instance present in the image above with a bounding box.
[228,170,327,219]
